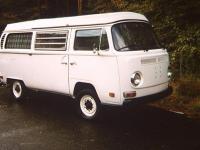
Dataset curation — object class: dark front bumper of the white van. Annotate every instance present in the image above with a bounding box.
[123,86,173,105]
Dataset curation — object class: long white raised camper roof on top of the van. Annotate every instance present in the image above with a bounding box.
[4,12,148,31]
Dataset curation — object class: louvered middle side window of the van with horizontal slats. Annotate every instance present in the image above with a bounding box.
[35,31,68,51]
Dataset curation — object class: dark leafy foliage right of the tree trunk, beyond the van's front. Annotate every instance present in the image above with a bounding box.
[83,0,200,79]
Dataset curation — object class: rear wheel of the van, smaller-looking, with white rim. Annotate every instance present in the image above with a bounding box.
[11,80,26,102]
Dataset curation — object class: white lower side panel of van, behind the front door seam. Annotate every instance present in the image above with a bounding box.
[0,53,69,94]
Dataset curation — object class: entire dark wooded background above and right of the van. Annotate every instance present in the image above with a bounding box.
[0,0,200,79]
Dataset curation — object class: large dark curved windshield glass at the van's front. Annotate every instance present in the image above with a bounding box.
[112,22,161,51]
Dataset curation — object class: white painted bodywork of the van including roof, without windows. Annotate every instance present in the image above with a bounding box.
[0,12,169,105]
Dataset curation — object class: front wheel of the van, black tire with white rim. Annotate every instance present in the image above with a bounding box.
[76,89,101,120]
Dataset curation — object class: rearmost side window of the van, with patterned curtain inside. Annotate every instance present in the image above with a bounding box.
[5,33,32,49]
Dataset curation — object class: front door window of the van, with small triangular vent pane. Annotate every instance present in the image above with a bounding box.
[74,29,109,51]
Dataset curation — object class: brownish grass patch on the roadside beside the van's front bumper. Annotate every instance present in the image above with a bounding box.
[153,78,200,119]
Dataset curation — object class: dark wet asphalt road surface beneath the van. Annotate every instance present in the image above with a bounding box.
[0,88,200,150]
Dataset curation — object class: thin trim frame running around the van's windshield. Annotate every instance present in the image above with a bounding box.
[111,20,163,52]
